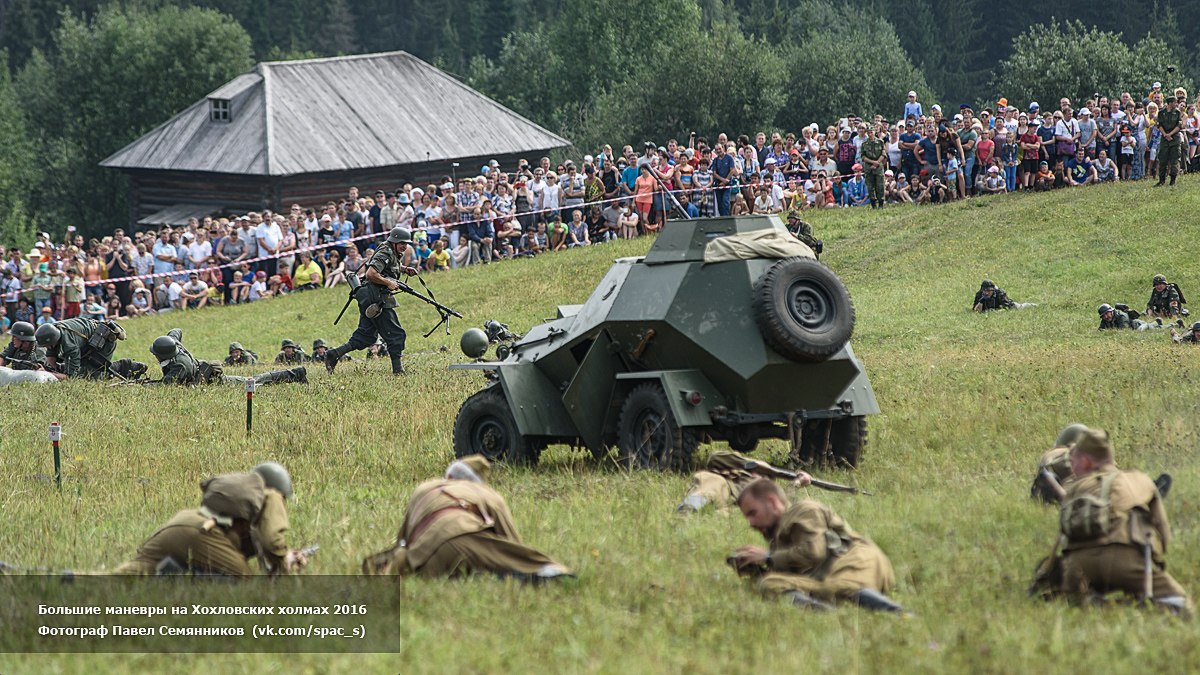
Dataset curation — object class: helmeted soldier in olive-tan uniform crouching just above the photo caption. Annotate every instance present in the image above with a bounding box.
[114,461,307,578]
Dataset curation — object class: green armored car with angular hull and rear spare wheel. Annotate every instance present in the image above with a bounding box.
[451,216,880,470]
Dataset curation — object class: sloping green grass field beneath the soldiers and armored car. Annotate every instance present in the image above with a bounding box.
[0,179,1200,674]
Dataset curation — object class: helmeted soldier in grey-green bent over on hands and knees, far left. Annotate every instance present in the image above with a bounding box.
[34,317,146,380]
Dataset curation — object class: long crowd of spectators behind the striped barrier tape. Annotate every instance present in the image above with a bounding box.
[0,83,1200,331]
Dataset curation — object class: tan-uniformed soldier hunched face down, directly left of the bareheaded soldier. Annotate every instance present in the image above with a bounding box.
[362,455,571,581]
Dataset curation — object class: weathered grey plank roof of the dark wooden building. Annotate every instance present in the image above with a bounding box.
[101,52,570,177]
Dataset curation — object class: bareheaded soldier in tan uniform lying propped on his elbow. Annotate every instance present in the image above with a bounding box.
[728,478,905,614]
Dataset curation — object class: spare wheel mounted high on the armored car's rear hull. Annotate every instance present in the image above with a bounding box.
[754,258,854,362]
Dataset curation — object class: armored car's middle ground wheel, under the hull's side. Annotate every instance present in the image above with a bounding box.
[617,383,700,471]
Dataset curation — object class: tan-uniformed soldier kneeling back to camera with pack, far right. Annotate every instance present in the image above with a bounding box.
[1058,429,1190,614]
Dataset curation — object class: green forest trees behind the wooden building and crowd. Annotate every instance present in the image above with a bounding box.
[0,0,1200,243]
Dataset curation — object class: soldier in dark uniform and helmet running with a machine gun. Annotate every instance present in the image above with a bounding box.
[325,226,416,375]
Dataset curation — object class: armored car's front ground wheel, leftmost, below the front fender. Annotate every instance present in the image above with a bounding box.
[454,387,539,465]
